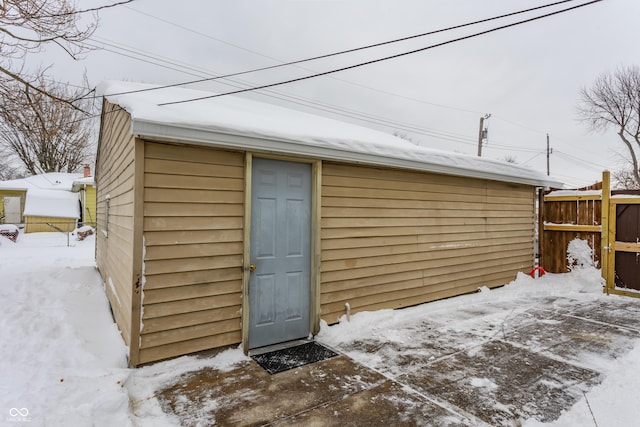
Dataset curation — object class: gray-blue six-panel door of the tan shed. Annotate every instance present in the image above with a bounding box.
[249,158,311,348]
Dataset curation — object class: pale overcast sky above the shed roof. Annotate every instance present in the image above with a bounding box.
[39,0,640,186]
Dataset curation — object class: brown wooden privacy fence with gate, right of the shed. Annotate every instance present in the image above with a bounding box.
[539,172,640,297]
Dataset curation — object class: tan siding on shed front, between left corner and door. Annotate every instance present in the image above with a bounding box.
[139,143,244,363]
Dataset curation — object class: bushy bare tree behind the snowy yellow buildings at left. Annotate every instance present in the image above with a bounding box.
[0,78,95,174]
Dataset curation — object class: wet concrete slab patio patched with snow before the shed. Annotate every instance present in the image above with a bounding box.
[158,295,640,426]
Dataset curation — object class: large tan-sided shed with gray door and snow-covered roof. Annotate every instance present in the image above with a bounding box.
[96,82,559,366]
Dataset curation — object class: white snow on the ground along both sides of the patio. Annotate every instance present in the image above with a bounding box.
[0,233,640,427]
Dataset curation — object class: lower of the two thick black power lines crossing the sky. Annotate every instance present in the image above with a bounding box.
[158,0,602,106]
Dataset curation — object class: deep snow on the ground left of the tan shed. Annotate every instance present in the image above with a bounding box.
[0,233,244,427]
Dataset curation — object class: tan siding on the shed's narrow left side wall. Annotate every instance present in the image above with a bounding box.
[95,103,135,346]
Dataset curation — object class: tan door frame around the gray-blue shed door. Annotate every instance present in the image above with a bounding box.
[241,152,322,354]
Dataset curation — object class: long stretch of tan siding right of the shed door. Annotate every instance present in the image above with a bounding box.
[320,163,535,323]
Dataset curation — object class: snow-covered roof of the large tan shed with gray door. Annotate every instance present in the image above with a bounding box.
[98,81,562,187]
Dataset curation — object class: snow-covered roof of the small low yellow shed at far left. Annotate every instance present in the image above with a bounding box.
[24,188,80,219]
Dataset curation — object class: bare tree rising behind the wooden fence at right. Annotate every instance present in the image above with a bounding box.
[578,66,640,185]
